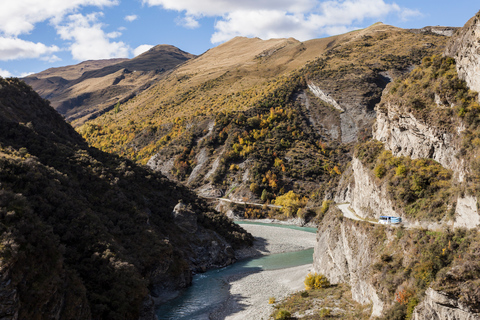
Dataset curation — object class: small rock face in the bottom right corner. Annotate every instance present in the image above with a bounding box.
[412,288,480,320]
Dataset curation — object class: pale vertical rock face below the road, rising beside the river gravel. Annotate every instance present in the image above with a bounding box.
[313,209,384,316]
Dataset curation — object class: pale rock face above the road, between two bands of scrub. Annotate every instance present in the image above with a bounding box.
[373,103,465,182]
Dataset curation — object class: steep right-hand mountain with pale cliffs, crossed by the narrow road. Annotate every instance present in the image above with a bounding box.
[314,12,480,320]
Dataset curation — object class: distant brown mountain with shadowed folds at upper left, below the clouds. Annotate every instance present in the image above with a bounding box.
[23,45,194,125]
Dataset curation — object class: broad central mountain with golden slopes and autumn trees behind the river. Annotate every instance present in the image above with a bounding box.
[78,23,448,221]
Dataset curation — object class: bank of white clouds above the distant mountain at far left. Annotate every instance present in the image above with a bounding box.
[0,0,130,62]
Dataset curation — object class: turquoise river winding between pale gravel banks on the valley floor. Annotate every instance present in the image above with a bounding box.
[156,223,316,320]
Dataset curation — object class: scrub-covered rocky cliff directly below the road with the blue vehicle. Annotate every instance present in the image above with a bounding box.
[314,208,480,320]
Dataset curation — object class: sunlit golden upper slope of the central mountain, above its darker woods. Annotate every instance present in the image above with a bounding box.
[79,23,446,163]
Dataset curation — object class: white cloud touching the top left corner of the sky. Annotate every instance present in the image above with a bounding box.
[0,0,118,36]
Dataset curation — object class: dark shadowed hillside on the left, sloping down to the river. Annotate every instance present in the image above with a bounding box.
[0,79,252,319]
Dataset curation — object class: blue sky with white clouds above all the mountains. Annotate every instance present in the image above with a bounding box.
[0,0,480,77]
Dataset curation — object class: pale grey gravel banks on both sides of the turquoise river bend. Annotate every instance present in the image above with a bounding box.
[210,224,316,320]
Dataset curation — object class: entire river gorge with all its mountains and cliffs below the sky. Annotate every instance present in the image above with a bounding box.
[0,6,480,320]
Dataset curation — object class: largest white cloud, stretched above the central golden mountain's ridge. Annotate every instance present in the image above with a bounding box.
[143,0,419,43]
